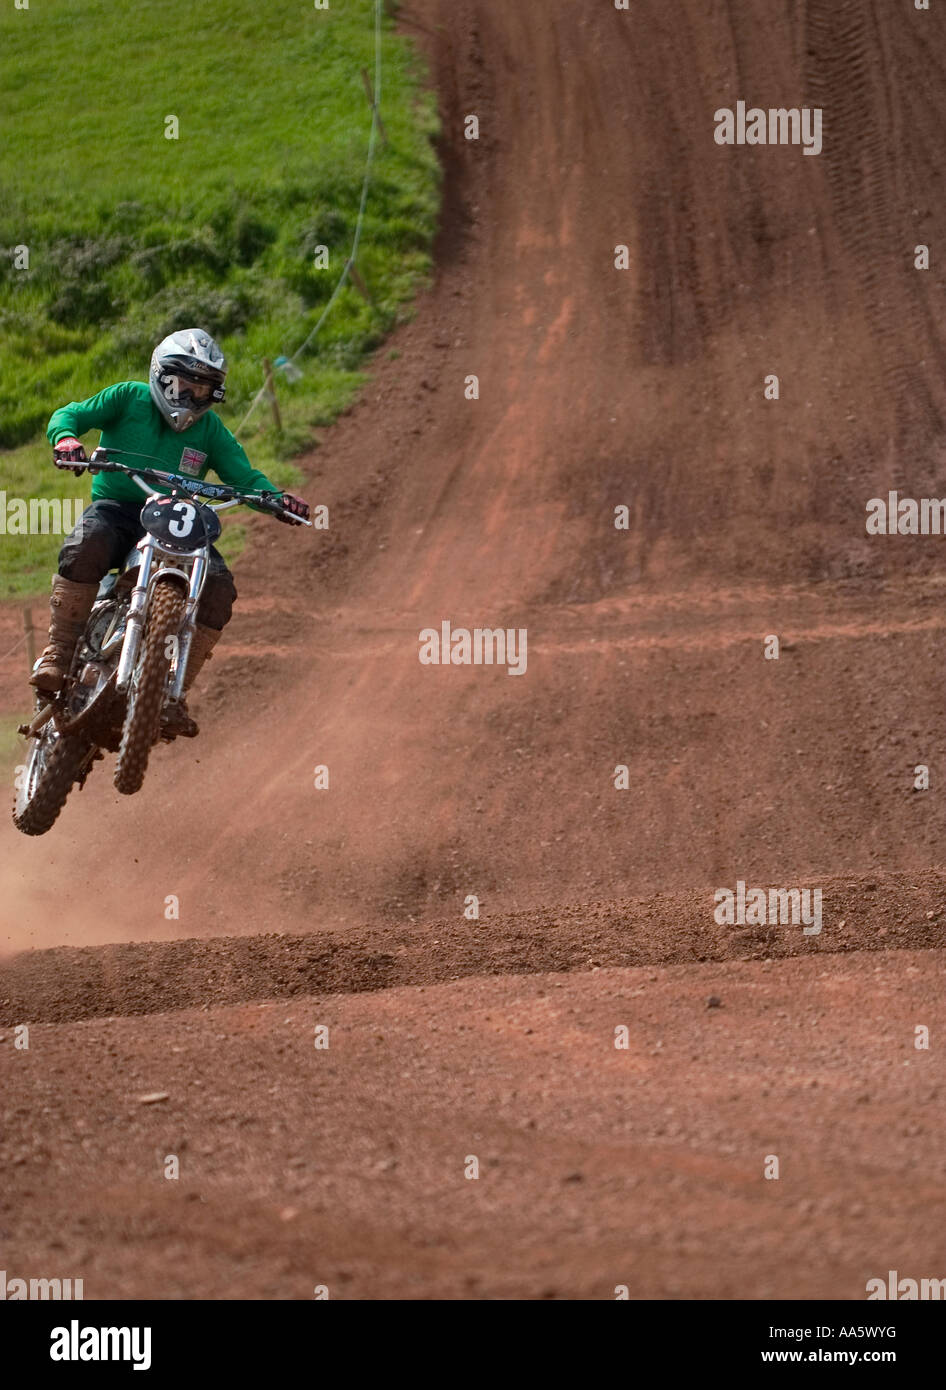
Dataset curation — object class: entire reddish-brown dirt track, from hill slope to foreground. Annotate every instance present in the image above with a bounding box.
[0,0,946,1298]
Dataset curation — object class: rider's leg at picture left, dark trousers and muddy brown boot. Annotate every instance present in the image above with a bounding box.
[29,498,142,694]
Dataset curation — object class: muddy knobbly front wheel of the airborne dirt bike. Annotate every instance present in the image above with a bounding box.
[114,580,185,796]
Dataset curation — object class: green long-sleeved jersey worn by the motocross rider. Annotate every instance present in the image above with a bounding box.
[46,381,281,502]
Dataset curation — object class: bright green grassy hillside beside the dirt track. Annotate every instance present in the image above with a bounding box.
[0,0,439,596]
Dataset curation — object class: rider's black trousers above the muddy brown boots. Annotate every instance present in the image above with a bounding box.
[60,498,236,631]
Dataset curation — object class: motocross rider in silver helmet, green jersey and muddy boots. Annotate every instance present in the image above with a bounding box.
[31,328,308,738]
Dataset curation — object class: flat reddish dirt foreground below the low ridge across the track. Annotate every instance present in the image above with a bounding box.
[0,951,946,1298]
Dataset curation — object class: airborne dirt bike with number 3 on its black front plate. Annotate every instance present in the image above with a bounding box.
[13,449,311,835]
